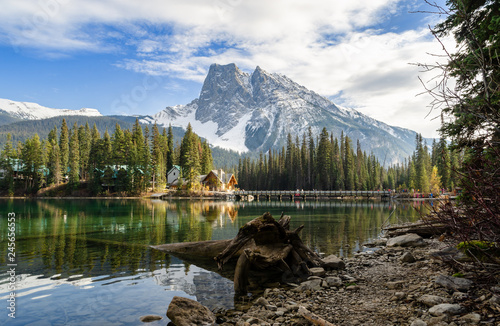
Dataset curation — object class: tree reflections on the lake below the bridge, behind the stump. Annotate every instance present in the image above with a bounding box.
[231,200,426,256]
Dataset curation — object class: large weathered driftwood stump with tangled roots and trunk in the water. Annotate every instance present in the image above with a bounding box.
[153,213,324,294]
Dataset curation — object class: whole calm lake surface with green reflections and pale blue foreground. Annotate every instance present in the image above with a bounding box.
[0,199,420,326]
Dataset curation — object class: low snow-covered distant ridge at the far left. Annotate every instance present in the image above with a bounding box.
[0,99,102,120]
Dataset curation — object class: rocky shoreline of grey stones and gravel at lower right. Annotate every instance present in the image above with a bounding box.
[165,234,500,326]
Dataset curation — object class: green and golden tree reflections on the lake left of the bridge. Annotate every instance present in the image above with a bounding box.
[0,199,242,276]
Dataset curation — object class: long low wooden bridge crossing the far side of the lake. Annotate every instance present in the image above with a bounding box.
[234,190,391,200]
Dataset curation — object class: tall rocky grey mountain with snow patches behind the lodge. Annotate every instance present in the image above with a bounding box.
[141,63,422,164]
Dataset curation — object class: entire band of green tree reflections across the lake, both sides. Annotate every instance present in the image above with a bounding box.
[0,199,426,276]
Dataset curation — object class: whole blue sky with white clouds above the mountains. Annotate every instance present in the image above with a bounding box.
[0,0,453,137]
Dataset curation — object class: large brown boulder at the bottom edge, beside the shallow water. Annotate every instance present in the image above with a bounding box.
[167,296,215,326]
